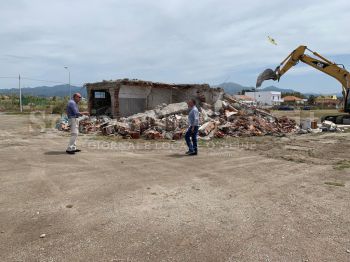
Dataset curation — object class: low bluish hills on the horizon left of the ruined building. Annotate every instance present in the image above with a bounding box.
[0,85,86,97]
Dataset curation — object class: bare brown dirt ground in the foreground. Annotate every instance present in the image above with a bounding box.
[0,114,350,262]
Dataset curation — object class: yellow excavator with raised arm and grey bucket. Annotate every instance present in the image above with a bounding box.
[256,46,350,124]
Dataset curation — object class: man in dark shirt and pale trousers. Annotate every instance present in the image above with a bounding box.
[66,93,88,155]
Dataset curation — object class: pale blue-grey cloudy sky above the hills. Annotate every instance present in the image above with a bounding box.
[0,0,350,93]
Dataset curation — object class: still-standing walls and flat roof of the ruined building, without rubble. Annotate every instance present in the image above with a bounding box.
[85,79,224,118]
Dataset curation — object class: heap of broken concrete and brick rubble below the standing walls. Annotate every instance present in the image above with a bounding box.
[56,94,298,140]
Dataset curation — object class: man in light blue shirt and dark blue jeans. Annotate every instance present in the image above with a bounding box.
[185,99,199,156]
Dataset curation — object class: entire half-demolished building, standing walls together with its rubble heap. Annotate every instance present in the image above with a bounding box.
[57,79,298,140]
